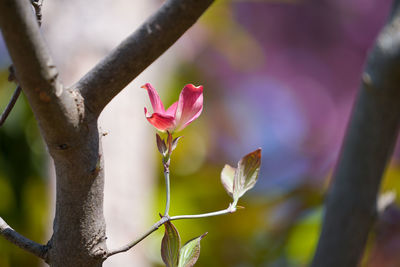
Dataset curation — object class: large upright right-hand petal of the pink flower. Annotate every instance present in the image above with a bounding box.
[175,84,203,131]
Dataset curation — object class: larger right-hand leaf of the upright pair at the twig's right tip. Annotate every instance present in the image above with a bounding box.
[233,148,261,201]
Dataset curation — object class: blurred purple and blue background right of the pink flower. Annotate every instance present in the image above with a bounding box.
[191,0,391,193]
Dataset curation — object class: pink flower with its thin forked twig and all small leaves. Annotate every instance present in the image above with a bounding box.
[118,83,261,267]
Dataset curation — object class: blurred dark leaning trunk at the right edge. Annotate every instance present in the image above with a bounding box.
[312,0,400,267]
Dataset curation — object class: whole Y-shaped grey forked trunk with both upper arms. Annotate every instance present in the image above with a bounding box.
[0,0,213,267]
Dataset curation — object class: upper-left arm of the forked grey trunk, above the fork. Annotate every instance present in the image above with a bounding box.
[0,0,79,148]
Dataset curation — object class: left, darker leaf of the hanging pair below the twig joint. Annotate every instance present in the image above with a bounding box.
[161,221,181,267]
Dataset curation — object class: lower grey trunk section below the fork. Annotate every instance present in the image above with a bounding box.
[49,124,107,267]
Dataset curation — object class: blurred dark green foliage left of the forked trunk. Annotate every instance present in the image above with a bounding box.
[0,70,49,267]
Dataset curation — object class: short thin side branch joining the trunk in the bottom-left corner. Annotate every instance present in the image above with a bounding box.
[0,217,48,262]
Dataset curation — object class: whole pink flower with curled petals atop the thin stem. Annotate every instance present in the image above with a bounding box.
[142,83,203,132]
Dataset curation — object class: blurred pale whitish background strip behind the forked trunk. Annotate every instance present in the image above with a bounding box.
[41,0,177,267]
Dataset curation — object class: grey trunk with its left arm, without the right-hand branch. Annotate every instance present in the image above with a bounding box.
[0,0,106,267]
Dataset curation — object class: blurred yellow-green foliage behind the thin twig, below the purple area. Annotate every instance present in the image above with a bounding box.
[153,80,400,267]
